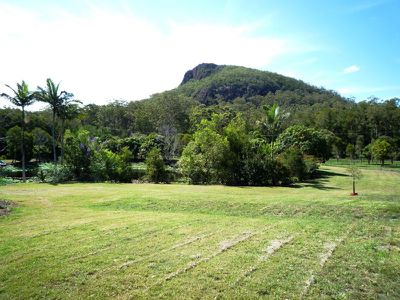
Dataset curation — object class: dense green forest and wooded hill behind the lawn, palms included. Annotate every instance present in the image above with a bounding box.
[0,64,400,185]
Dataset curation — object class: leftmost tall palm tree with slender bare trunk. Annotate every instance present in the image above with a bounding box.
[0,81,35,182]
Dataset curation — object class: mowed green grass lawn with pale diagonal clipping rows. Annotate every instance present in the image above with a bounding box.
[0,167,400,299]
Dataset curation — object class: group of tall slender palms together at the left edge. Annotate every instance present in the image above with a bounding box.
[0,78,80,182]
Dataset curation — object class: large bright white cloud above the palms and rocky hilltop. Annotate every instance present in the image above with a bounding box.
[0,4,314,103]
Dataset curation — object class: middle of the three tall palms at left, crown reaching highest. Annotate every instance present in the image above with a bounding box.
[35,78,74,164]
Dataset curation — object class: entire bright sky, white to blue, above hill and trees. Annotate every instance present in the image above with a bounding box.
[0,0,400,106]
